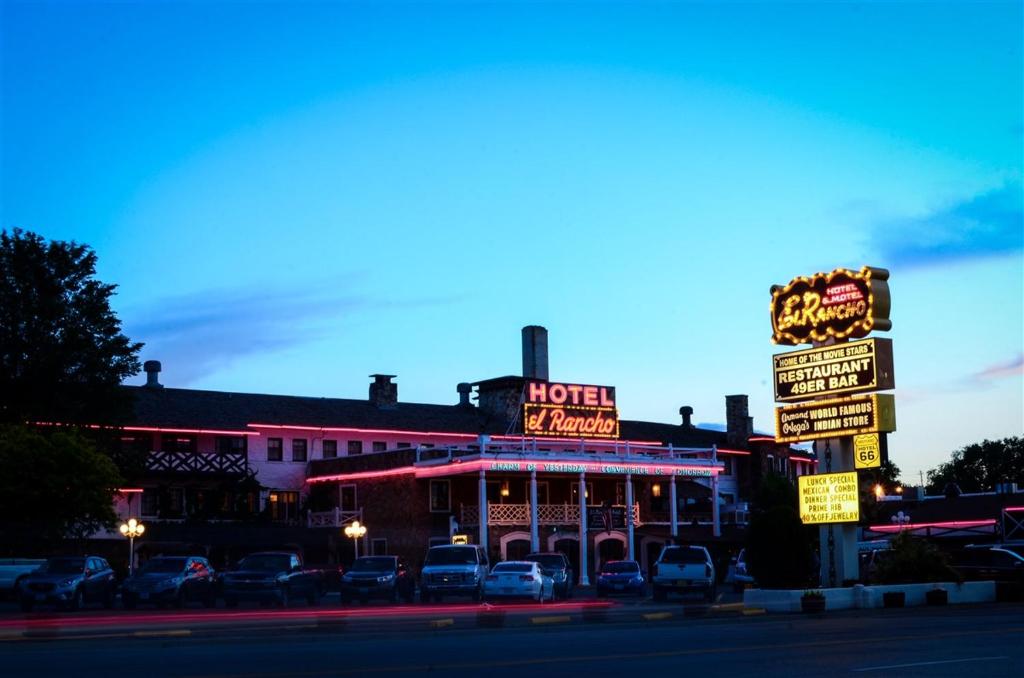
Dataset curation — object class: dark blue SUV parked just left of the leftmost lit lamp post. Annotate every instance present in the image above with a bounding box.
[18,556,117,612]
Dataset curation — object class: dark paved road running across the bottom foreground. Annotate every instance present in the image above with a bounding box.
[0,604,1024,678]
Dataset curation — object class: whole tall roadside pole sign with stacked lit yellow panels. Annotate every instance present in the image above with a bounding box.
[770,266,896,586]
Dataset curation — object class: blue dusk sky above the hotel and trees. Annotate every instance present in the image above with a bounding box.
[0,2,1024,476]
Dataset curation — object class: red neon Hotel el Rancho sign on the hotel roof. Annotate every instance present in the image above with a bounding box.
[522,381,618,438]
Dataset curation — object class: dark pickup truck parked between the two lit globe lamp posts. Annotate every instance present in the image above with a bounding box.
[221,551,324,607]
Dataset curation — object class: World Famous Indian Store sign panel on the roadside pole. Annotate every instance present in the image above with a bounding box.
[775,393,896,442]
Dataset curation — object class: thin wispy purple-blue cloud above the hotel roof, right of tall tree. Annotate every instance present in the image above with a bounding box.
[125,282,453,385]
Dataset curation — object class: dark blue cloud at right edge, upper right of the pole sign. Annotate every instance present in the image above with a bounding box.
[871,179,1024,266]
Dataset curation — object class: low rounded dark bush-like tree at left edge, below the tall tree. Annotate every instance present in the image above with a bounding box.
[0,424,121,555]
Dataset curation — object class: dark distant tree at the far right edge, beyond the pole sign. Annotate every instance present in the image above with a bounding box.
[928,437,1024,494]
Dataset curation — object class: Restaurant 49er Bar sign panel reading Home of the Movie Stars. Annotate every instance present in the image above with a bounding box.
[773,338,896,402]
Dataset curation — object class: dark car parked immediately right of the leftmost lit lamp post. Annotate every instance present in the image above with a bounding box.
[121,556,217,609]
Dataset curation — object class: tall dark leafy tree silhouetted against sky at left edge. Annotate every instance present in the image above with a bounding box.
[0,228,142,425]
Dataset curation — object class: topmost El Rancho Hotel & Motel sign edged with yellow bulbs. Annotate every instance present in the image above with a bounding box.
[771,266,892,345]
